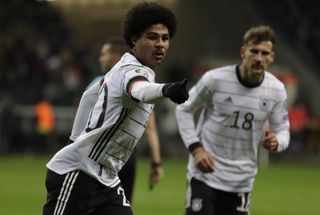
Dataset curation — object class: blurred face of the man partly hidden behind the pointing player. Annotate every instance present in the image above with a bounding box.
[99,44,120,72]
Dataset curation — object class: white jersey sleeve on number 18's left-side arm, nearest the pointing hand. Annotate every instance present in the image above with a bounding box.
[176,73,212,148]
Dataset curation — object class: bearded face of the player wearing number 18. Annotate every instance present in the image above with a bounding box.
[241,41,275,77]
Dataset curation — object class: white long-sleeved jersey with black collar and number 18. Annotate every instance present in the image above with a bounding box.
[176,65,289,192]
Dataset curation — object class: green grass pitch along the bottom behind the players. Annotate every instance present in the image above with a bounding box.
[0,156,320,215]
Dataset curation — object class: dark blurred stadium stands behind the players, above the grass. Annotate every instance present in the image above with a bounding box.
[0,0,320,159]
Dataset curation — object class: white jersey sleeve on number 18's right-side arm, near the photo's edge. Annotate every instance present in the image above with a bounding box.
[269,86,290,152]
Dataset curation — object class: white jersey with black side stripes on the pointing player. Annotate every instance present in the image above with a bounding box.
[47,53,154,187]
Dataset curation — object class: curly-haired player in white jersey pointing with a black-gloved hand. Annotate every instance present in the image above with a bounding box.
[43,3,188,215]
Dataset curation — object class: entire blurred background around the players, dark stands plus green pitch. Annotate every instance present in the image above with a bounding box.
[0,0,320,215]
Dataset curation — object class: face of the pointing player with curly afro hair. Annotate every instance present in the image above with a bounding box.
[132,24,169,69]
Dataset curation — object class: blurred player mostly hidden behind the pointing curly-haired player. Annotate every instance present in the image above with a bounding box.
[69,37,163,203]
